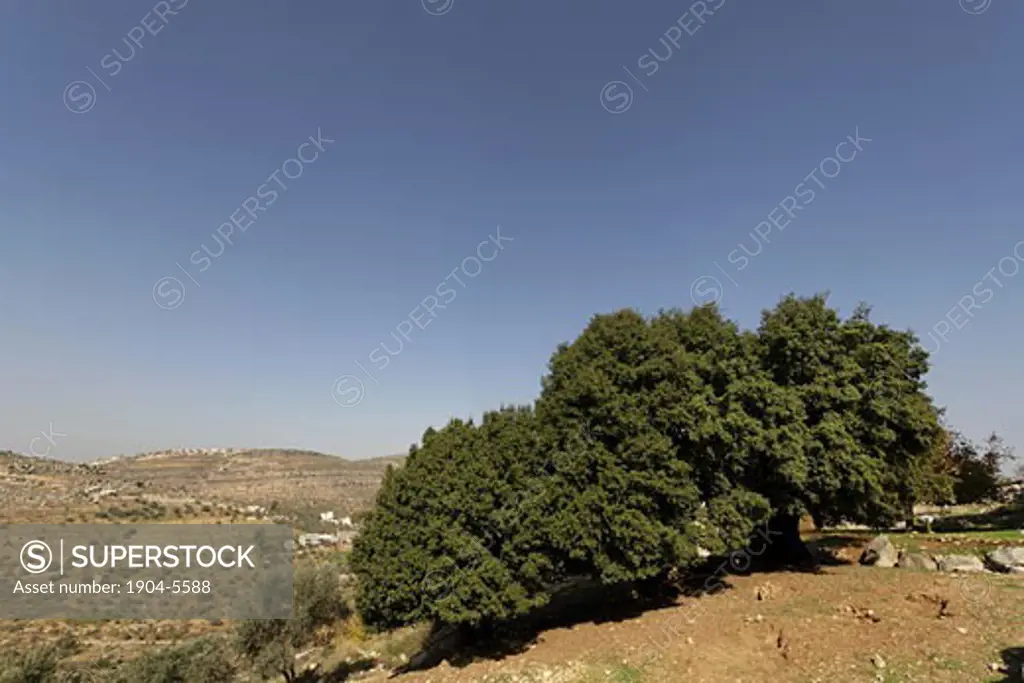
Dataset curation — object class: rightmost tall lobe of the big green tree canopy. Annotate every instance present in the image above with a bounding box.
[758,297,939,525]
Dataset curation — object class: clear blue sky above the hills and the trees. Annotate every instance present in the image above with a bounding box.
[0,0,1024,460]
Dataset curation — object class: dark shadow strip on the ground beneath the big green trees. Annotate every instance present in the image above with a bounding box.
[394,539,843,676]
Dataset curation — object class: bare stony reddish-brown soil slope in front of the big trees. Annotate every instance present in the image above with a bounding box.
[372,565,1024,683]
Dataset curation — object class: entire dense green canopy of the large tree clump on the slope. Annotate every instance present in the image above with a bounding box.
[351,296,949,628]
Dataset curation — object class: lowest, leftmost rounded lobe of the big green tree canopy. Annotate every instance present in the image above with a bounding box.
[350,408,561,627]
